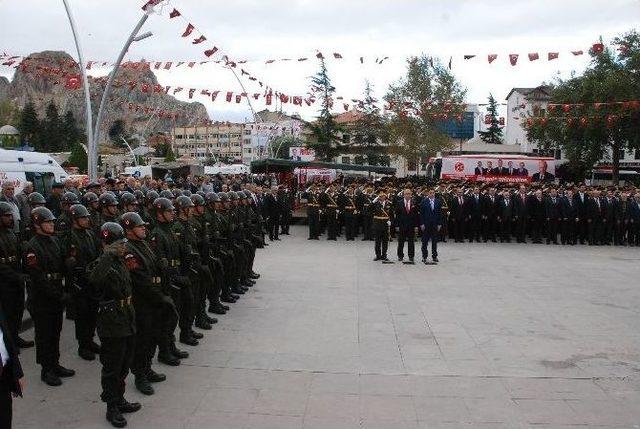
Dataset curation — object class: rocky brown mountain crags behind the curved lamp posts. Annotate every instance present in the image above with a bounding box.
[0,51,209,140]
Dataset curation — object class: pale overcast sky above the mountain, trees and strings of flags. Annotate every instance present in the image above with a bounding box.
[0,0,640,120]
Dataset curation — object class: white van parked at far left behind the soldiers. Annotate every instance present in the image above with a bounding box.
[0,149,69,195]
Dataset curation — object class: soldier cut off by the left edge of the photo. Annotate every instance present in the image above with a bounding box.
[0,201,25,344]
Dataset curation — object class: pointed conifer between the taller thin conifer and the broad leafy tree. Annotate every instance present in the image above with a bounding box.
[349,81,389,166]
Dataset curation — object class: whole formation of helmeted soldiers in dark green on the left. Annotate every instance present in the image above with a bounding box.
[0,191,265,427]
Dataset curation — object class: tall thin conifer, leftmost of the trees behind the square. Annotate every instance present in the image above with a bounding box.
[307,58,343,161]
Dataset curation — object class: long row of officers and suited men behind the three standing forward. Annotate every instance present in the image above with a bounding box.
[301,185,640,246]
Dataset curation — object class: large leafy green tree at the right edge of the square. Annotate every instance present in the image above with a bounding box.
[523,30,640,184]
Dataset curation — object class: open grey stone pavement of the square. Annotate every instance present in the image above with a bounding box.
[15,227,640,429]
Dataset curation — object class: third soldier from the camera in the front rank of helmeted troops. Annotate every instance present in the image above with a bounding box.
[151,197,198,348]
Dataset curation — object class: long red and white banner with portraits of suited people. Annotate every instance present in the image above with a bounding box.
[440,155,556,183]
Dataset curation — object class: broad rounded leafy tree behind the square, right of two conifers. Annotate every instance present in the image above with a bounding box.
[385,55,466,172]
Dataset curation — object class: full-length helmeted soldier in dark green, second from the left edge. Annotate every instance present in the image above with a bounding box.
[25,207,75,386]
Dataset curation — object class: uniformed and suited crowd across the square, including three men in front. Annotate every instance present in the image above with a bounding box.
[301,179,640,262]
